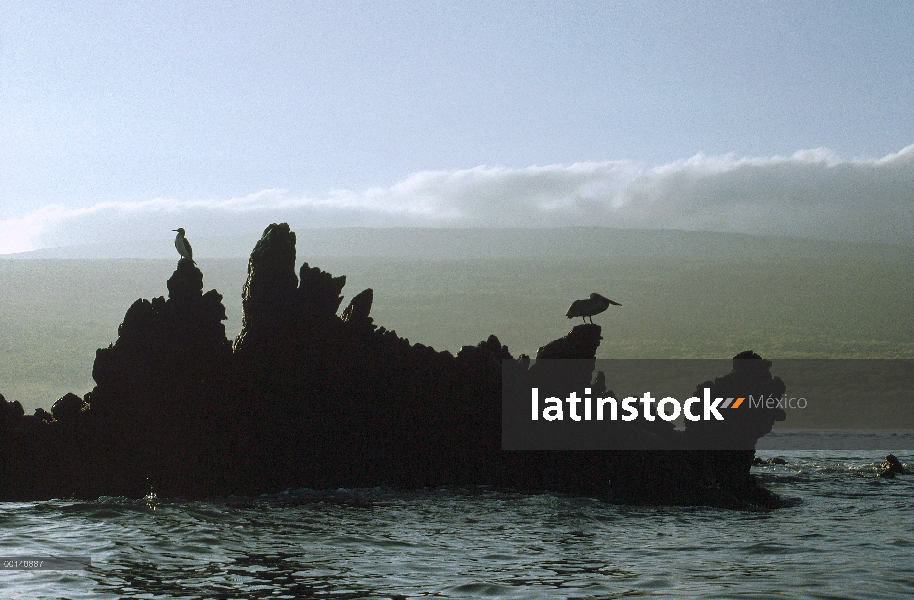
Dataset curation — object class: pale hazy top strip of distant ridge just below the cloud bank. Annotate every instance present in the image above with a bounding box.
[7,227,914,262]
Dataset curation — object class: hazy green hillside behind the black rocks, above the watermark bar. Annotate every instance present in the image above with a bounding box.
[0,229,914,411]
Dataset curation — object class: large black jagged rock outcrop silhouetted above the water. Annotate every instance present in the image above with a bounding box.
[0,223,783,508]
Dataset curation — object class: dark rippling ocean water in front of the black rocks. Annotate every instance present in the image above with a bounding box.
[0,449,914,599]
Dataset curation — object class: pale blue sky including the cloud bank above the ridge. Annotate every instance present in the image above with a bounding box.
[0,0,914,254]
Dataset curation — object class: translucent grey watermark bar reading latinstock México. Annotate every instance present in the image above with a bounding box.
[502,352,914,450]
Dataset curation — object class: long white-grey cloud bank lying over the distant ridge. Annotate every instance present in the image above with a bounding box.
[0,145,914,253]
